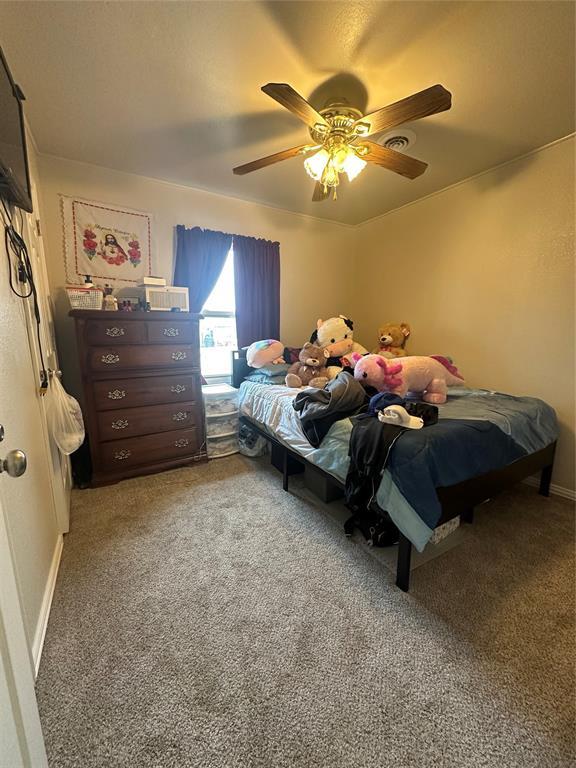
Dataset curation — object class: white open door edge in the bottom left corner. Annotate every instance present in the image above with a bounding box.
[0,480,48,768]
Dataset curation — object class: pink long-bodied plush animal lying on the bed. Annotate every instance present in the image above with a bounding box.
[351,355,464,404]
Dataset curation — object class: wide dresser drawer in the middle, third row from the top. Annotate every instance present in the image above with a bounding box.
[93,373,200,411]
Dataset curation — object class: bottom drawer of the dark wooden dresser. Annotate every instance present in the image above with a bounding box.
[100,429,200,472]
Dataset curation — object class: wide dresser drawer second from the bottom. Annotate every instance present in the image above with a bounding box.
[98,403,198,440]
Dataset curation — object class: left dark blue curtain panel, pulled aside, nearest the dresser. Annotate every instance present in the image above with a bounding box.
[174,224,232,312]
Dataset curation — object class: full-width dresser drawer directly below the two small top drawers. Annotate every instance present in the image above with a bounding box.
[88,344,200,371]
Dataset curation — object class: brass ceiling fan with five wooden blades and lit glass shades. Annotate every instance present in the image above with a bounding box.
[234,83,452,202]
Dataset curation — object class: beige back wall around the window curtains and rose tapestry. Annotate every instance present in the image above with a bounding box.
[40,156,356,400]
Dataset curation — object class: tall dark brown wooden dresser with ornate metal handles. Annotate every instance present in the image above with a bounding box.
[70,309,206,486]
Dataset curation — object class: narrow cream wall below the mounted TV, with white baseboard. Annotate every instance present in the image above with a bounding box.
[0,201,62,664]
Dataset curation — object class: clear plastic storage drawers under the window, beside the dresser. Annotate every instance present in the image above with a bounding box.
[202,384,238,459]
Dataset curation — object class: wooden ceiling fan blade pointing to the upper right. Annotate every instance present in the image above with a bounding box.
[354,85,452,136]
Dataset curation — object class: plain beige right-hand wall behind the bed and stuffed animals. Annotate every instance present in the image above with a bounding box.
[354,137,575,490]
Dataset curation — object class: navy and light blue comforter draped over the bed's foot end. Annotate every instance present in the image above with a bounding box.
[376,387,558,551]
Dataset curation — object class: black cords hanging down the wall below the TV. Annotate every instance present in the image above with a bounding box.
[0,199,48,391]
